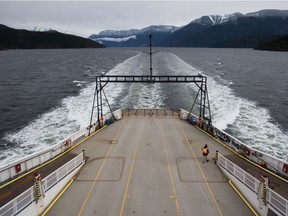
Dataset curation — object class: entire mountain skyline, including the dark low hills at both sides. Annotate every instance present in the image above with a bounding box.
[0,10,288,51]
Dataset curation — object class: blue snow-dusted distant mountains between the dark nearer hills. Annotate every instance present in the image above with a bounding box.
[89,10,288,48]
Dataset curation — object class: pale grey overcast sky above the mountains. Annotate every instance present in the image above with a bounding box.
[0,0,288,37]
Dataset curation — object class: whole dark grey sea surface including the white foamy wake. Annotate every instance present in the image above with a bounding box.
[0,48,288,166]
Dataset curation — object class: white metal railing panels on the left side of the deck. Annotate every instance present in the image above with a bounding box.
[0,153,83,216]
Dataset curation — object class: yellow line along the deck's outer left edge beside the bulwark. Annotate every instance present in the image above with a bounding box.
[0,125,107,189]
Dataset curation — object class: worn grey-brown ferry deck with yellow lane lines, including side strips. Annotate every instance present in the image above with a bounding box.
[0,112,288,216]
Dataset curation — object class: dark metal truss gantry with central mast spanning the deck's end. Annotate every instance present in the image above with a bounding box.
[89,34,212,135]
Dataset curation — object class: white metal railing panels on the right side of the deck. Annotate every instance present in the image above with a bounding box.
[218,153,288,215]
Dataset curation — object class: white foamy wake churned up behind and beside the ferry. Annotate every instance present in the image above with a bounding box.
[0,52,288,165]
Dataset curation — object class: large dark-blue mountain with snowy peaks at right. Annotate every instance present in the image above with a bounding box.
[160,10,288,48]
